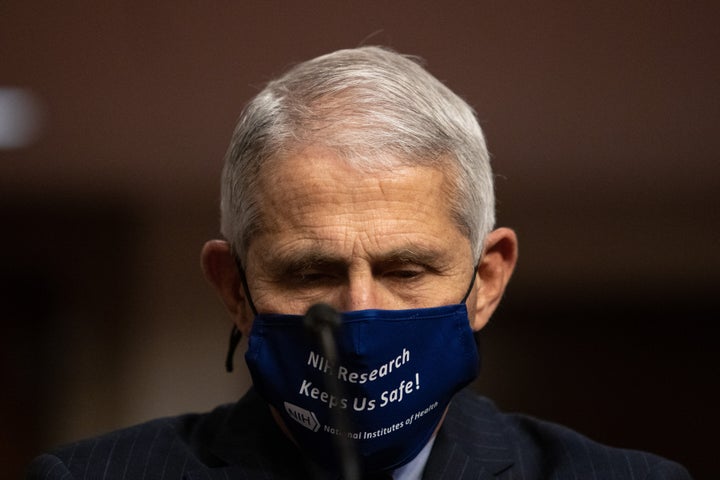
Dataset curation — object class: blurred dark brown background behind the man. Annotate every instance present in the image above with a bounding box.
[0,0,720,478]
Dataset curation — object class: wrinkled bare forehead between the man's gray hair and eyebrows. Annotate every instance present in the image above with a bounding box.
[250,148,467,262]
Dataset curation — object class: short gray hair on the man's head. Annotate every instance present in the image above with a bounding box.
[220,47,495,261]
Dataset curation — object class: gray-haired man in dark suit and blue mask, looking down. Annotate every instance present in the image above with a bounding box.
[31,47,689,479]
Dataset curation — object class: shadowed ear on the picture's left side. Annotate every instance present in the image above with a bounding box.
[200,240,253,337]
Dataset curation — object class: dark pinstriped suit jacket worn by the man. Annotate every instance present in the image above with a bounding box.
[28,390,690,480]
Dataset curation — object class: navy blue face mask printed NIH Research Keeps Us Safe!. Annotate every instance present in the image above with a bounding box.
[245,291,479,472]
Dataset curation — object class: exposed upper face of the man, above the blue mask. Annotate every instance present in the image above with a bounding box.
[245,148,475,315]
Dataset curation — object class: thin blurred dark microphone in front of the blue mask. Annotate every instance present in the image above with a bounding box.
[303,303,360,480]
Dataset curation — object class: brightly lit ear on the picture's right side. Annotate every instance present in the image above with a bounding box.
[470,228,518,332]
